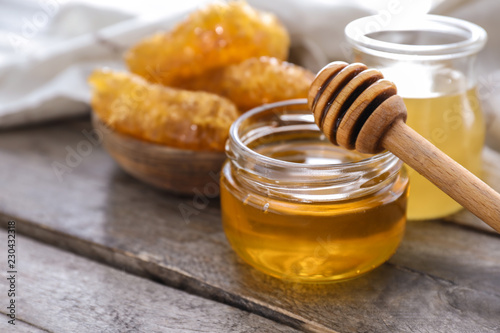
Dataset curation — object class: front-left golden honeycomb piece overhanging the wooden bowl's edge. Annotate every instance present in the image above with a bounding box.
[89,70,238,151]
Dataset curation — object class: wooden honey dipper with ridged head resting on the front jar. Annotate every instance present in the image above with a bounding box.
[308,62,500,233]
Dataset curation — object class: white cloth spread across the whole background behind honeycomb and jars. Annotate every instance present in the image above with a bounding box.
[0,0,500,149]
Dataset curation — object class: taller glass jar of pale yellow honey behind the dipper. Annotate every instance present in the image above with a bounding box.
[345,15,486,220]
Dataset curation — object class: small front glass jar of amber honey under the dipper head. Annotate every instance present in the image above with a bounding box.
[221,99,408,283]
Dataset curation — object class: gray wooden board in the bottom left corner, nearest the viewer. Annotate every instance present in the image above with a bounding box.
[0,230,296,333]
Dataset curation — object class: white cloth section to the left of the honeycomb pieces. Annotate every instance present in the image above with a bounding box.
[0,0,209,127]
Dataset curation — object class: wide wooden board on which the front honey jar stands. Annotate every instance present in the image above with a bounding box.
[0,121,500,332]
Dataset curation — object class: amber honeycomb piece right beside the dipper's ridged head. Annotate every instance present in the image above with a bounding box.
[178,57,314,111]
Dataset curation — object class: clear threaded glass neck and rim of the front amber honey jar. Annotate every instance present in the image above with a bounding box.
[226,100,402,202]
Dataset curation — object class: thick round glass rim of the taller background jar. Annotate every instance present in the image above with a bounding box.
[345,15,487,60]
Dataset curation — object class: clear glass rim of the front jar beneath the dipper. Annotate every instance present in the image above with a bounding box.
[226,98,395,170]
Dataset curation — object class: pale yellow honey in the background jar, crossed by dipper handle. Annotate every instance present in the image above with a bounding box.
[404,89,485,219]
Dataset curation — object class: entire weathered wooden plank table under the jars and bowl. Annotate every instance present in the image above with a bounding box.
[0,118,500,333]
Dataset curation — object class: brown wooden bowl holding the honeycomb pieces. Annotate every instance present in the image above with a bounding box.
[92,113,226,196]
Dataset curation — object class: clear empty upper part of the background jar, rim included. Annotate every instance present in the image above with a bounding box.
[345,15,487,98]
